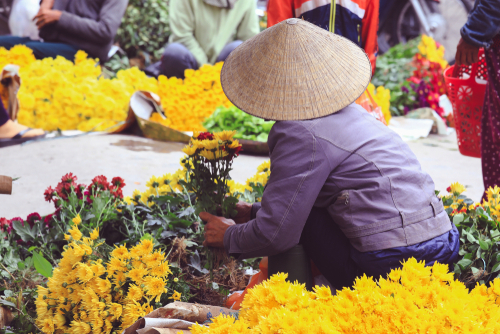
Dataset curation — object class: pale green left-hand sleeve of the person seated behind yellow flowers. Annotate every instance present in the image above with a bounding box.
[169,0,208,66]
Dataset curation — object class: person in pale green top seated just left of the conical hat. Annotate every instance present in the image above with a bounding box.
[159,0,260,78]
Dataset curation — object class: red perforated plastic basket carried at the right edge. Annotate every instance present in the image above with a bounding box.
[444,49,488,158]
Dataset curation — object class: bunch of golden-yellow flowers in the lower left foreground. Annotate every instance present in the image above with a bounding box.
[35,225,171,334]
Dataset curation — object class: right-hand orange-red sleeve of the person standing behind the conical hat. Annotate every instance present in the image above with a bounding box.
[361,0,379,75]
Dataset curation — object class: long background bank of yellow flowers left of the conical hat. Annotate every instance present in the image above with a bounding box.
[0,45,232,131]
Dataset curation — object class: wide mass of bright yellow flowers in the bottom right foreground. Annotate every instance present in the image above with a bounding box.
[192,259,500,334]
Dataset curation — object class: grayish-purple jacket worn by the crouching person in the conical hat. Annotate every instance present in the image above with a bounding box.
[224,104,451,258]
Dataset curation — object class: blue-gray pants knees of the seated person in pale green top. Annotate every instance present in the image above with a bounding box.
[160,41,243,79]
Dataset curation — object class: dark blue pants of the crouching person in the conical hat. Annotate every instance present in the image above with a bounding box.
[300,207,460,289]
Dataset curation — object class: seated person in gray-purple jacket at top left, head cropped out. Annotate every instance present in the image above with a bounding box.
[0,0,128,63]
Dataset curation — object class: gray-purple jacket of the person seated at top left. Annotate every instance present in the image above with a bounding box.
[39,0,128,63]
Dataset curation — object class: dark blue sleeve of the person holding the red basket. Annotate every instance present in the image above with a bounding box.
[460,0,500,48]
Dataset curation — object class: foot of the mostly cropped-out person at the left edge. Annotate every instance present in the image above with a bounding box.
[0,100,45,147]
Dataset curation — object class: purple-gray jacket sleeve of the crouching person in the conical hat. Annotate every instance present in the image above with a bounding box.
[224,122,331,259]
